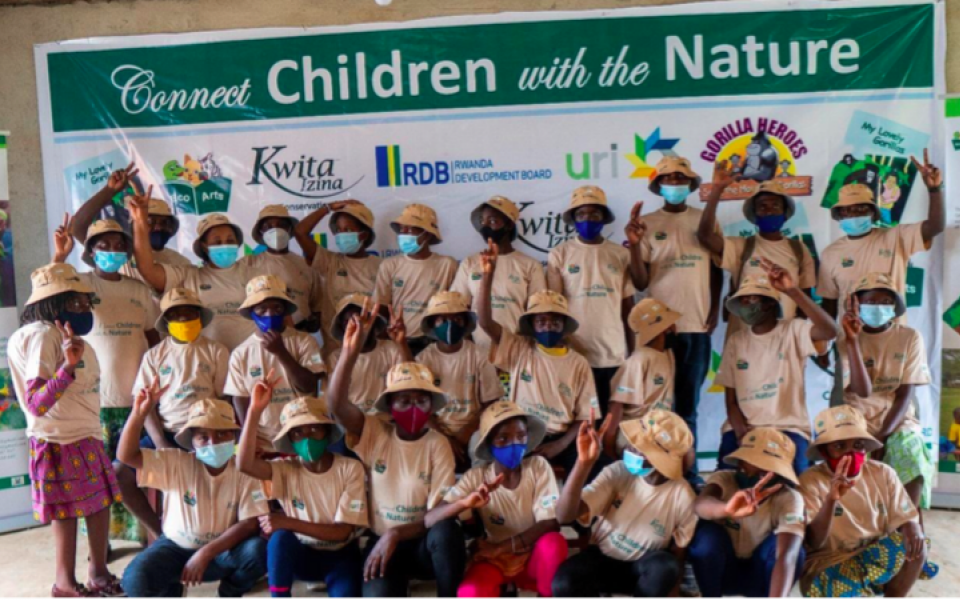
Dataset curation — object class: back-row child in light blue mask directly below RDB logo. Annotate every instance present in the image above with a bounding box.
[374,204,457,356]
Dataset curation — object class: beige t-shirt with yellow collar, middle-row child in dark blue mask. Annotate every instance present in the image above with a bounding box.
[493,329,603,434]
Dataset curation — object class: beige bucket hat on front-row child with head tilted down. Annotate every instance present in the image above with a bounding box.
[620,409,693,481]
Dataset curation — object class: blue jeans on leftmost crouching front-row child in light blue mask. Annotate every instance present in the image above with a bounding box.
[123,535,267,598]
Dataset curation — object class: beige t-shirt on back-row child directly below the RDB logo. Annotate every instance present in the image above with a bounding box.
[374,253,457,338]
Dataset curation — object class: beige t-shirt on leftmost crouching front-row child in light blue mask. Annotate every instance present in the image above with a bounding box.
[137,450,270,550]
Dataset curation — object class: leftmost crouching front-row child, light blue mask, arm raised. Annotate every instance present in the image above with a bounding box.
[118,396,270,598]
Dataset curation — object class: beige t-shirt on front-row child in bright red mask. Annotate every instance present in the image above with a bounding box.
[800,459,918,577]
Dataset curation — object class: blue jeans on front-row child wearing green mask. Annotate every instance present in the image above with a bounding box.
[267,530,363,598]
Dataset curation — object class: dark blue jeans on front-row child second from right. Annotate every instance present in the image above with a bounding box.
[687,521,806,598]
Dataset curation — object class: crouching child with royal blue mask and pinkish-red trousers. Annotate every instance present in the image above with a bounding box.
[426,401,567,598]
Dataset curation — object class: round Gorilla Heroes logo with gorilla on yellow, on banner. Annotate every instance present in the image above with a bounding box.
[700,117,813,200]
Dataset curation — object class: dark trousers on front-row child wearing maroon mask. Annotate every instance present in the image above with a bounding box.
[363,519,467,598]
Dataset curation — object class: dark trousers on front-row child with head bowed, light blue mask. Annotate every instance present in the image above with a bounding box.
[553,546,681,598]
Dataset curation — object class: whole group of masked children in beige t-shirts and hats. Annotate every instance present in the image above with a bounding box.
[8,150,944,597]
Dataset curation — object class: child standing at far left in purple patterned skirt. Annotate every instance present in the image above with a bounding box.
[7,263,123,597]
